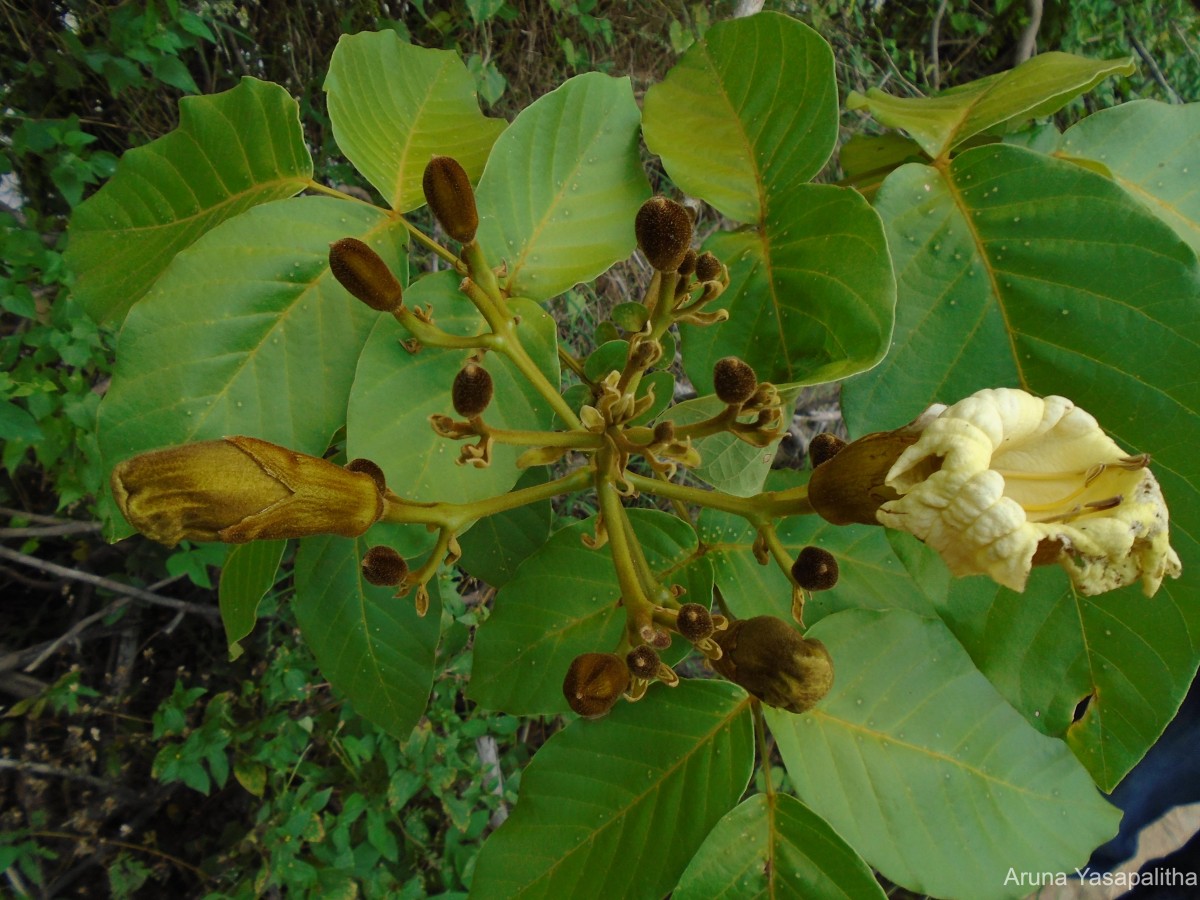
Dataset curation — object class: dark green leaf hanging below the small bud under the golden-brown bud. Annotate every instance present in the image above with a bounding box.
[293,535,442,738]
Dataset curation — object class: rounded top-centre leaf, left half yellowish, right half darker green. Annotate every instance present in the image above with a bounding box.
[642,13,838,222]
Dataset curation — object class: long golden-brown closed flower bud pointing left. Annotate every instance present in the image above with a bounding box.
[112,437,384,546]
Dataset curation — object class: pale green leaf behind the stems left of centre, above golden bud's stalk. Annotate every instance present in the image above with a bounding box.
[347,270,559,503]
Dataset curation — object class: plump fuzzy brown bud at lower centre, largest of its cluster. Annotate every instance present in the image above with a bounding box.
[709,616,833,713]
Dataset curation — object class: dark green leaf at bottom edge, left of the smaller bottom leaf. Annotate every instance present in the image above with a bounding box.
[472,680,754,900]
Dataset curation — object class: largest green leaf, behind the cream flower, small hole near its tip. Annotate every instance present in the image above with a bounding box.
[842,146,1200,787]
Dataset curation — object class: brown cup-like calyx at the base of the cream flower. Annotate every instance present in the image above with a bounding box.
[809,431,918,524]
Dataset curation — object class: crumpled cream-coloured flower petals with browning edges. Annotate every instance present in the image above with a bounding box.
[876,389,1181,596]
